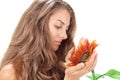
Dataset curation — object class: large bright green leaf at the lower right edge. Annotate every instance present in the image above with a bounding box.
[106,69,120,80]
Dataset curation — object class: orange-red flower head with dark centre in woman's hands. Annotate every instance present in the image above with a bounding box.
[68,38,98,66]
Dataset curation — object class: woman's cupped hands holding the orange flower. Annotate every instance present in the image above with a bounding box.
[64,48,97,80]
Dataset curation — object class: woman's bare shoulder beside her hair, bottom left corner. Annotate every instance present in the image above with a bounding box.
[0,64,16,80]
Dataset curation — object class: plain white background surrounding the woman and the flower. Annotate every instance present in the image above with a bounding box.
[0,0,120,80]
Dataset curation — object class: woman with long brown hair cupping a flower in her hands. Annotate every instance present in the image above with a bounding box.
[0,0,97,80]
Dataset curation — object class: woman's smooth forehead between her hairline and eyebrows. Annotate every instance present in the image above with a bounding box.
[50,8,70,25]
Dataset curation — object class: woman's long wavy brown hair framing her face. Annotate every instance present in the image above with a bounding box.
[0,0,76,80]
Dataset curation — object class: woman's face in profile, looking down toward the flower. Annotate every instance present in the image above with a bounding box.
[48,9,70,51]
